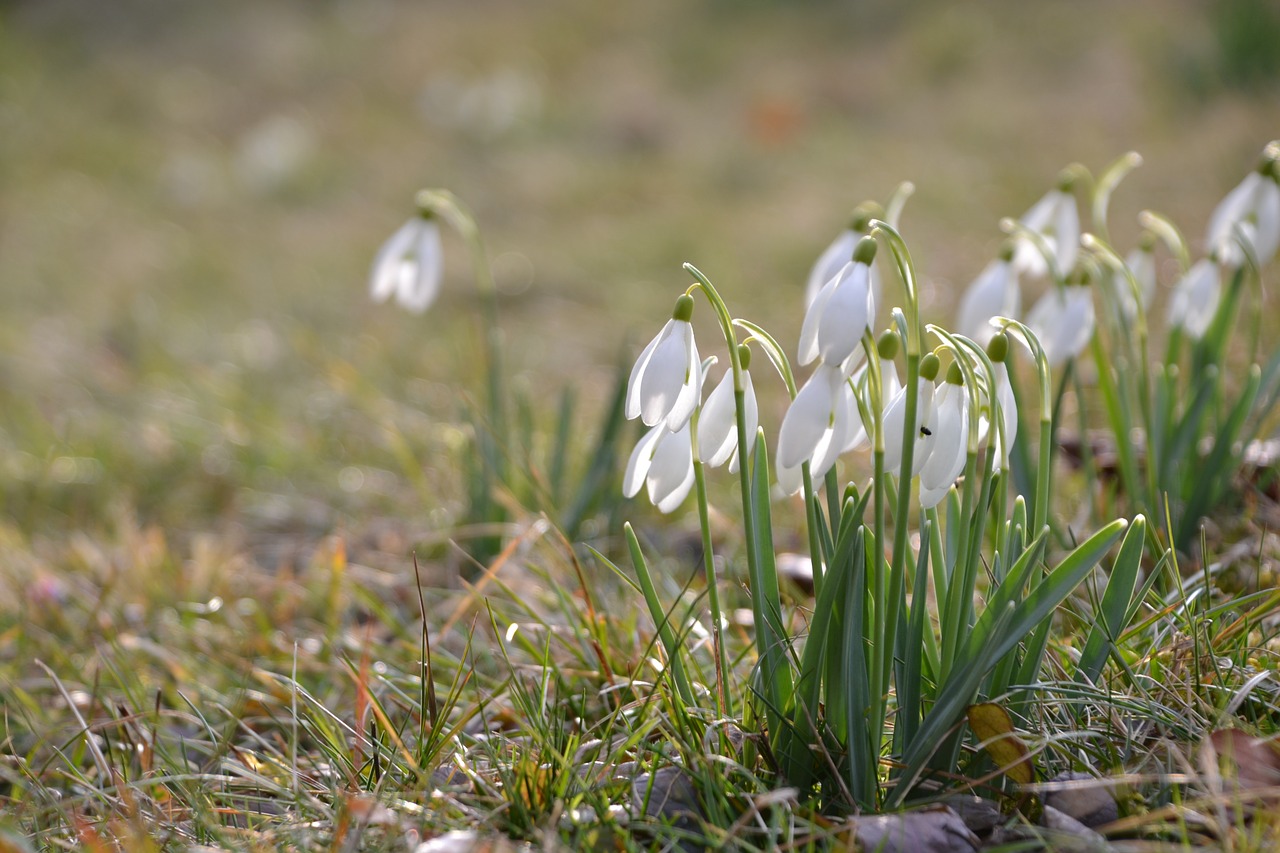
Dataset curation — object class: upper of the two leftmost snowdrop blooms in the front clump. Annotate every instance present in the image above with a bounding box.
[626,293,703,432]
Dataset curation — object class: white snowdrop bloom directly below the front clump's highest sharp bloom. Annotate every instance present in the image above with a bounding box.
[777,362,859,478]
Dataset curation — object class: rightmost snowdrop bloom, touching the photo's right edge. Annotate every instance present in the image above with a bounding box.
[1204,149,1280,269]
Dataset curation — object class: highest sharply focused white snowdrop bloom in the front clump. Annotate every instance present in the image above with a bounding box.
[799,237,876,365]
